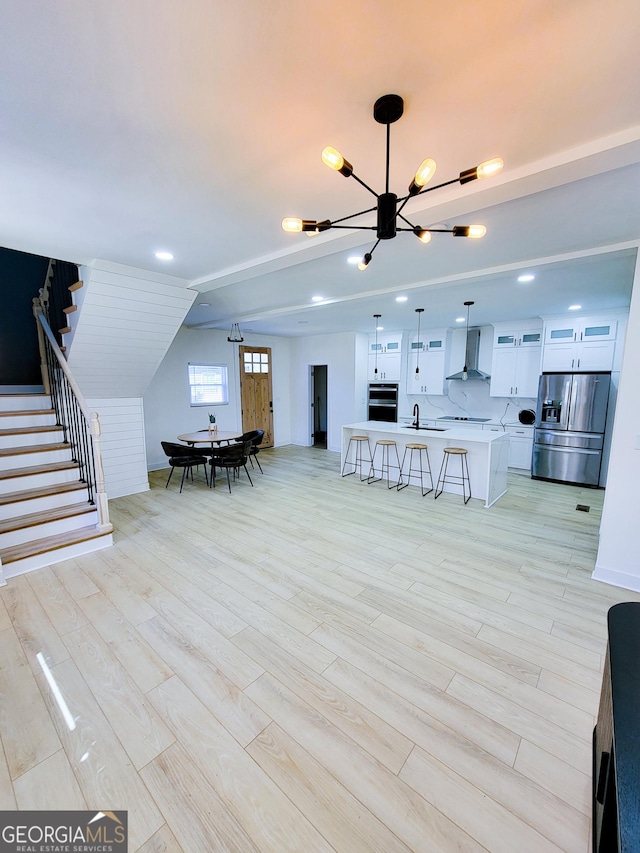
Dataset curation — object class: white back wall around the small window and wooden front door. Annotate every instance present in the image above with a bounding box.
[144,326,291,471]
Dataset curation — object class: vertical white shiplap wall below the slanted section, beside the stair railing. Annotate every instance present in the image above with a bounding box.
[87,397,149,498]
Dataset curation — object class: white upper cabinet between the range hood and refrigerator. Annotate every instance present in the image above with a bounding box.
[489,324,542,397]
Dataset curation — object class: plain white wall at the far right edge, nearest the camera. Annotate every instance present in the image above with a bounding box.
[593,250,640,591]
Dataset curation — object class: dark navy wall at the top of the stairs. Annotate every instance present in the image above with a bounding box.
[0,248,49,385]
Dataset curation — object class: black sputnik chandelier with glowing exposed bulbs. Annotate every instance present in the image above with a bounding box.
[282,95,504,270]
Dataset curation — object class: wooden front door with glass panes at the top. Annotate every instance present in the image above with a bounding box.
[239,347,273,447]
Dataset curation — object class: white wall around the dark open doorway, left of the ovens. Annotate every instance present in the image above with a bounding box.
[290,332,367,452]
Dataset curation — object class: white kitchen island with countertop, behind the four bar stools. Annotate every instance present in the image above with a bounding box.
[340,421,509,507]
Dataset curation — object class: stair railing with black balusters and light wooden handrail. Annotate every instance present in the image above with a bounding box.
[33,290,113,533]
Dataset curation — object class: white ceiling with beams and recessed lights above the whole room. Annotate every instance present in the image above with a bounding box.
[0,0,640,335]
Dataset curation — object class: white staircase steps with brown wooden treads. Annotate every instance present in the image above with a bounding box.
[0,394,112,584]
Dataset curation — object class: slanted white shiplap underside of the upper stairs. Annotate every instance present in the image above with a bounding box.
[65,261,197,399]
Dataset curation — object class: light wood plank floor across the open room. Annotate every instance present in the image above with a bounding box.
[0,447,638,853]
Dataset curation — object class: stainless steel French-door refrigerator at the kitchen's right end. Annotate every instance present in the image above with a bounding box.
[531,373,611,486]
